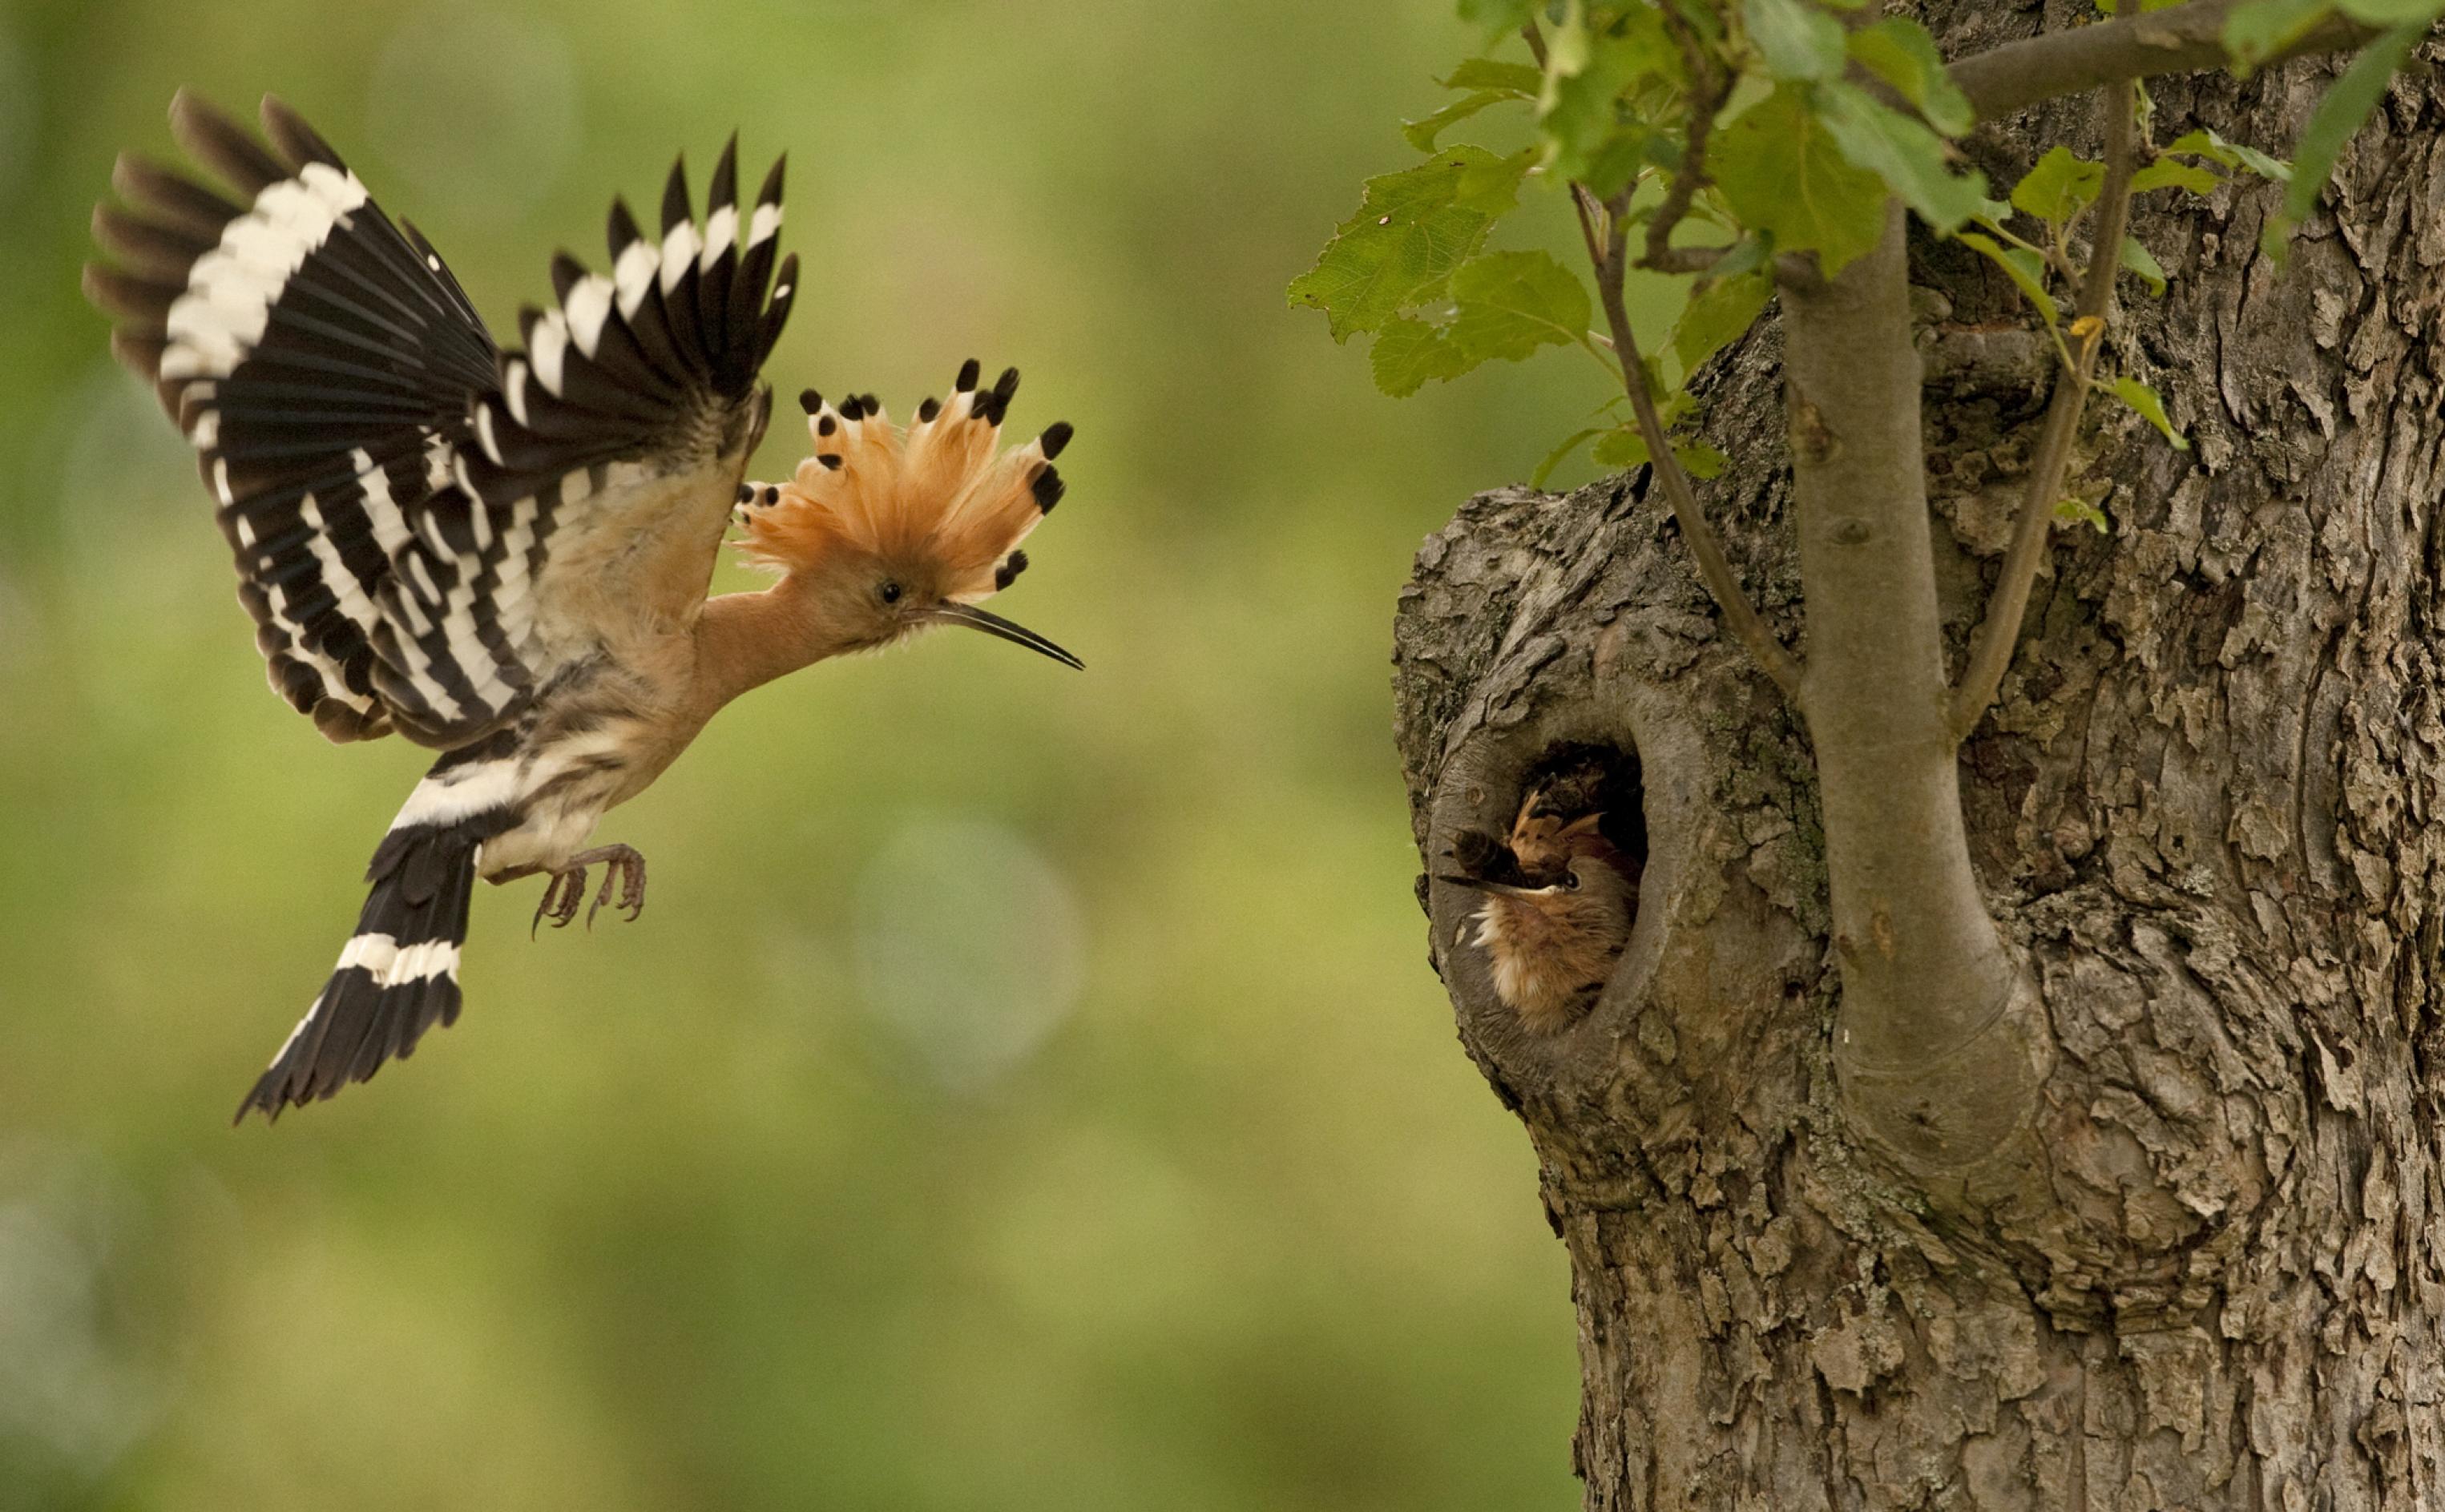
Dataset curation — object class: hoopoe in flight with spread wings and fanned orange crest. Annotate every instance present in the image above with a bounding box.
[86,91,1078,1118]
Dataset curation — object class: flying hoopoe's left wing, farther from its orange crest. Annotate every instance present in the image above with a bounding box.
[86,91,498,741]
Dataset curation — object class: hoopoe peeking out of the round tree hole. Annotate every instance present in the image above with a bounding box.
[1442,773,1640,1035]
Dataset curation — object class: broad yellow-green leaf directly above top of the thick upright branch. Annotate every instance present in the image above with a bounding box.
[1707,83,1885,276]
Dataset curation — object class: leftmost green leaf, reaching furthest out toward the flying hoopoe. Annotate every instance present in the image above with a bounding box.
[1291,147,1528,340]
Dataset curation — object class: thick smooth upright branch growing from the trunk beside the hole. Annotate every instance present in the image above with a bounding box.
[1782,200,2052,1170]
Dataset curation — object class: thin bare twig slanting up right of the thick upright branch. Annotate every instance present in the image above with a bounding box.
[1951,0,2140,741]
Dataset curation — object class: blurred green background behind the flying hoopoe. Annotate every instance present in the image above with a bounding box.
[0,0,1643,1512]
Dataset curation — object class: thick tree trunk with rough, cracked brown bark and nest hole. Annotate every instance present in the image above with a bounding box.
[1396,0,2445,1510]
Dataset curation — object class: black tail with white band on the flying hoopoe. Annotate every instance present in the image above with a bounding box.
[237,778,518,1123]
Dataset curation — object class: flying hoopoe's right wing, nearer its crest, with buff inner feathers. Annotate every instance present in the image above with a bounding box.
[398,139,797,739]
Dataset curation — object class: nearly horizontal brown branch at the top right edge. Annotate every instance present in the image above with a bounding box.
[1951,0,2377,120]
